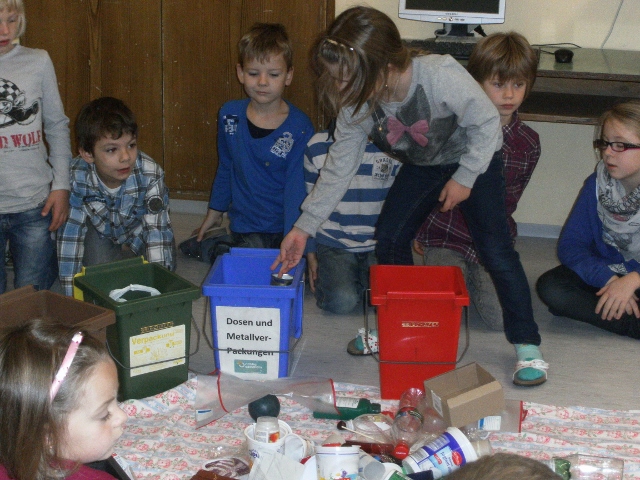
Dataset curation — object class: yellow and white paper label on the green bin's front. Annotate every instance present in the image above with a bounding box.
[129,325,187,377]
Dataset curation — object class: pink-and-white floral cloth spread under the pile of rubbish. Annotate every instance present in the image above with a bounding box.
[116,378,640,480]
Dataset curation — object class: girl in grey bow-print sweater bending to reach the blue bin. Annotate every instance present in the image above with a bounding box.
[276,7,548,385]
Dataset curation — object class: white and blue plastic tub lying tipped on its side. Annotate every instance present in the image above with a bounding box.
[402,427,493,479]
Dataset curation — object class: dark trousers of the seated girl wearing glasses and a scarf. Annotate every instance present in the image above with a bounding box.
[536,265,640,339]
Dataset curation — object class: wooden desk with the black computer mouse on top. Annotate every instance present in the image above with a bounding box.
[519,47,640,125]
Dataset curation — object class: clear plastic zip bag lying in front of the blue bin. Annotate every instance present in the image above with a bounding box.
[194,372,338,428]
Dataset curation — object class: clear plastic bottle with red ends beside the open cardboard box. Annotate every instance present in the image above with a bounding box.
[391,388,424,460]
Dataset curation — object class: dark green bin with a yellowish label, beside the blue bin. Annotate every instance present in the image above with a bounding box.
[73,257,200,400]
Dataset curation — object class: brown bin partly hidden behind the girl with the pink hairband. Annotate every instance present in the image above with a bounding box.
[0,285,116,342]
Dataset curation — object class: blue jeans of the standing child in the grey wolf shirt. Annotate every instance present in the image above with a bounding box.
[0,203,58,293]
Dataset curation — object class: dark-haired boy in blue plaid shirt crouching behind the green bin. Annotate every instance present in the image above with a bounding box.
[58,97,176,295]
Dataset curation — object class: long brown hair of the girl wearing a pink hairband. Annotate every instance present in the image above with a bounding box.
[0,319,112,480]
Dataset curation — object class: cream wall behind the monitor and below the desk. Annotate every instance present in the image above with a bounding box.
[336,0,640,235]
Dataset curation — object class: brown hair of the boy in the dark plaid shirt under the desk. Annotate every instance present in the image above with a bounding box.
[467,32,538,98]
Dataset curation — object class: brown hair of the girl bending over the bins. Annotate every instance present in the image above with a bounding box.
[311,6,413,117]
